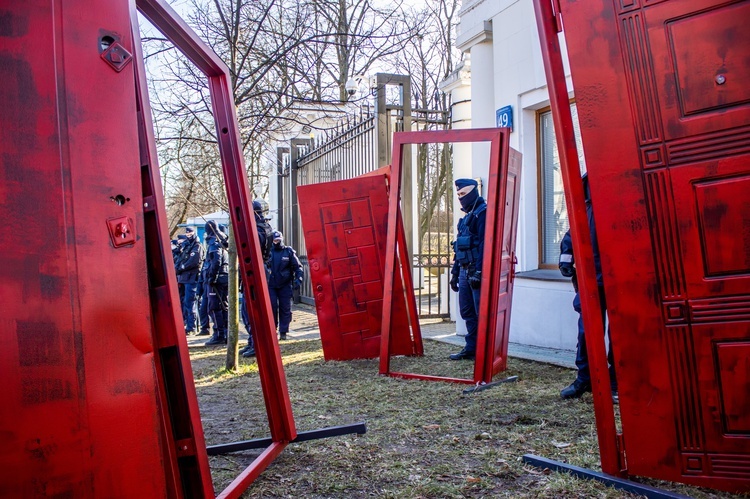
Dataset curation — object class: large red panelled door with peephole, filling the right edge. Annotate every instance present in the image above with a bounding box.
[562,0,750,491]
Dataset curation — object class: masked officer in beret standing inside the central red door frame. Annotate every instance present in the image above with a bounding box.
[450,178,487,360]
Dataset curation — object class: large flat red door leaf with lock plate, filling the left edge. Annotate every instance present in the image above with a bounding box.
[0,1,175,497]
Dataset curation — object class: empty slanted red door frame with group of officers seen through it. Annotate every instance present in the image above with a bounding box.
[131,0,297,498]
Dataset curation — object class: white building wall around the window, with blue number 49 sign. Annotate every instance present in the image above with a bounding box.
[457,0,578,350]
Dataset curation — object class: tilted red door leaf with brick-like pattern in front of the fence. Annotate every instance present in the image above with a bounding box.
[297,175,415,360]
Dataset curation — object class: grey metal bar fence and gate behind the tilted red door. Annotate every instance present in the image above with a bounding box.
[278,75,453,318]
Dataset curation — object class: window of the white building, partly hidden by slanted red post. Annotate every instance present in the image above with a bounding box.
[538,103,586,268]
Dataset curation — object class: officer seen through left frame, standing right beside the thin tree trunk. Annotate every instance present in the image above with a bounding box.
[206,220,229,346]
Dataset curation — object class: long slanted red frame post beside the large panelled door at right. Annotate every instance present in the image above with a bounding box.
[534,0,627,476]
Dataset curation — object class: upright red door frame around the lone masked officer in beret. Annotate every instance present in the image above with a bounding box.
[380,128,510,384]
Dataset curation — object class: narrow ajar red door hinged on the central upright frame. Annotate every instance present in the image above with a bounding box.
[482,148,521,380]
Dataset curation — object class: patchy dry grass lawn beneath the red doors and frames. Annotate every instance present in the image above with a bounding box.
[191,340,744,498]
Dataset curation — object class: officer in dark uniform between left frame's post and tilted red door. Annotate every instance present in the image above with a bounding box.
[268,231,303,340]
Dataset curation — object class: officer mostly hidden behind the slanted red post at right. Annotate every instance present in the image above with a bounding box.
[559,173,619,403]
